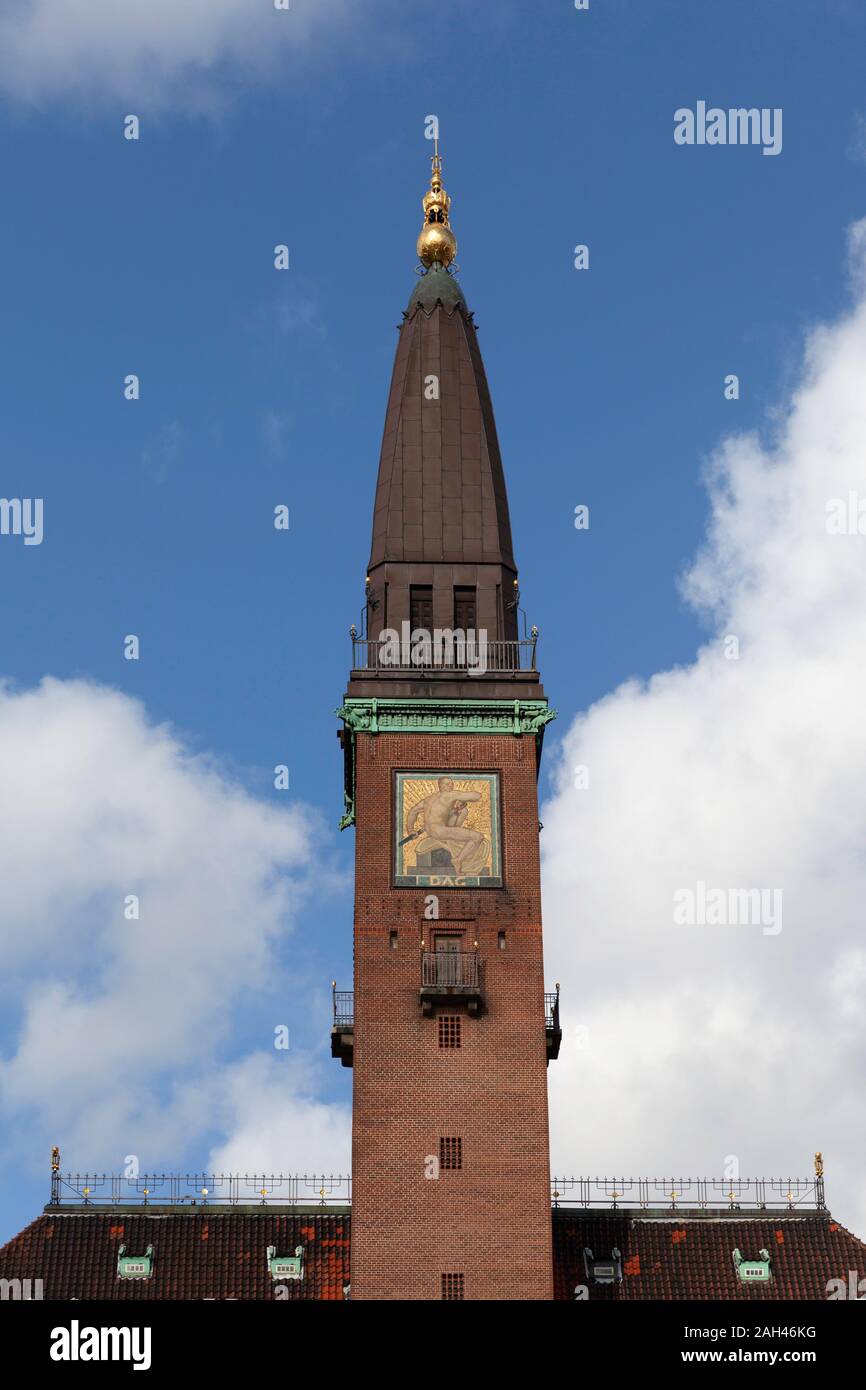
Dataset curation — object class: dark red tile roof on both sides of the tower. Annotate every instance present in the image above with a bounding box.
[0,1208,866,1301]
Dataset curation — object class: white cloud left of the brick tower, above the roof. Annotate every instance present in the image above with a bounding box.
[0,680,348,1168]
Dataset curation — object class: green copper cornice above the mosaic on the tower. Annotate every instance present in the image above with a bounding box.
[336,696,556,830]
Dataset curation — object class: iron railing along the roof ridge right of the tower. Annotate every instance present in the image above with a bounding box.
[550,1177,826,1212]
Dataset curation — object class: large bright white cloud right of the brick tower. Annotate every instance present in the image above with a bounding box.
[542,221,866,1234]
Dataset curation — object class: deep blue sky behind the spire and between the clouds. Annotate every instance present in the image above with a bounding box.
[0,0,866,1234]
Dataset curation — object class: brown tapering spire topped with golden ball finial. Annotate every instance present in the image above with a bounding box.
[367,150,525,680]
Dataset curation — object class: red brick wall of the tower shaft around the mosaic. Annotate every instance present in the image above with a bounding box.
[352,734,553,1300]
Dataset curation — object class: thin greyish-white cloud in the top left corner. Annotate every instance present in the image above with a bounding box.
[0,0,348,115]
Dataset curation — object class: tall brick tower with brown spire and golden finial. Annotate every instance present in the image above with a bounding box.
[332,152,560,1301]
